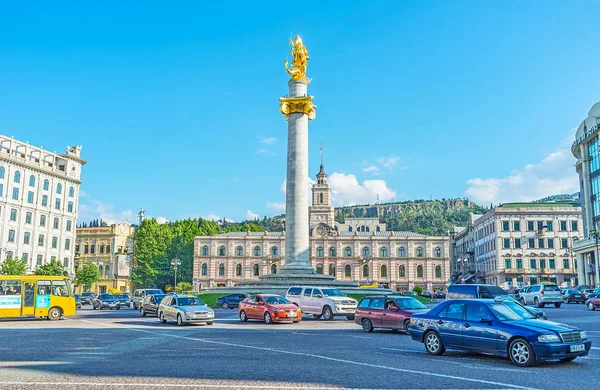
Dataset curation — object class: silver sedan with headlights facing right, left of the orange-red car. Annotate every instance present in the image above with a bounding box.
[158,294,215,326]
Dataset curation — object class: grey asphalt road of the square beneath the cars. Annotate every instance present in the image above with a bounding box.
[0,304,600,390]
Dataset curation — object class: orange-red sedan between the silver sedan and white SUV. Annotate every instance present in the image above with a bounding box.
[238,294,302,324]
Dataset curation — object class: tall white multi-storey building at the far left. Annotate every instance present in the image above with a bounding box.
[0,135,86,273]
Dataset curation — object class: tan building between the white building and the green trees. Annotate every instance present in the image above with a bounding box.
[75,222,135,293]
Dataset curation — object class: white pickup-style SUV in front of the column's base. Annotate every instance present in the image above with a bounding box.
[285,286,358,321]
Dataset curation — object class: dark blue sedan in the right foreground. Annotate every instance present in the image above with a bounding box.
[409,297,592,366]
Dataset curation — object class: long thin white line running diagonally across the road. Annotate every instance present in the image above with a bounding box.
[80,320,534,390]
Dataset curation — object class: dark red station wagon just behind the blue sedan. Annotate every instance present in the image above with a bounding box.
[354,295,428,333]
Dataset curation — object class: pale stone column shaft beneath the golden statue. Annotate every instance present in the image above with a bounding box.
[281,79,315,274]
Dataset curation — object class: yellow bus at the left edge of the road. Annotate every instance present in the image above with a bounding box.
[0,275,75,320]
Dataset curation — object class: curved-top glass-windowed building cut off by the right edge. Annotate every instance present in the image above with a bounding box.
[571,102,600,286]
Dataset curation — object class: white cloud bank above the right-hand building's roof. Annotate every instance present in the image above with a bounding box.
[465,134,579,206]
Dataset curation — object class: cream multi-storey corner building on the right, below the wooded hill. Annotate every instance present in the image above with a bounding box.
[468,202,583,287]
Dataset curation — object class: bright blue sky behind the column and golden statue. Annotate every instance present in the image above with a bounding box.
[0,1,600,221]
